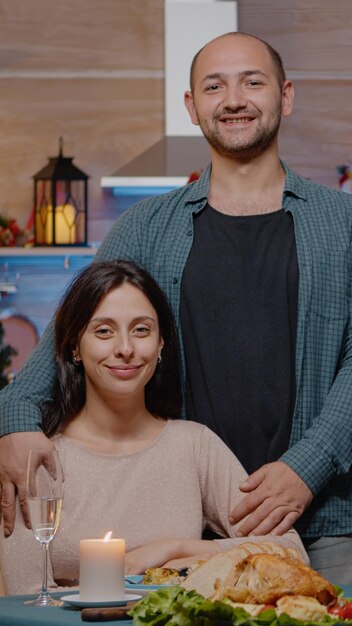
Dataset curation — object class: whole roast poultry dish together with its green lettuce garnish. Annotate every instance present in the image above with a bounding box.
[130,542,352,626]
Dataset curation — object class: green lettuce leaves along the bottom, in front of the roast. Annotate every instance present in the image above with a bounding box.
[128,585,351,626]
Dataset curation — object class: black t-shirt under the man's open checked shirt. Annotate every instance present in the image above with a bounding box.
[180,206,299,473]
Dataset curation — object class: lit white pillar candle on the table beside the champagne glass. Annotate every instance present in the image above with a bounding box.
[79,533,125,602]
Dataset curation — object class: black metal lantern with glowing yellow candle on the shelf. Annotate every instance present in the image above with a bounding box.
[33,139,89,246]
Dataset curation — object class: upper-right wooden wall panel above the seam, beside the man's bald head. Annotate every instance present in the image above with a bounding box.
[238,0,352,74]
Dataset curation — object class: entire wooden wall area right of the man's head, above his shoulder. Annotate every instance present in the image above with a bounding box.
[238,0,352,188]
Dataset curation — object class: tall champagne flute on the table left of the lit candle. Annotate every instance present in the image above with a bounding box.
[25,448,63,606]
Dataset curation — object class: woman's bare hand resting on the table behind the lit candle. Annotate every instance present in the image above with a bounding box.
[125,539,220,574]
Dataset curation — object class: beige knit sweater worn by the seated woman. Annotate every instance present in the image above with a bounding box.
[0,420,304,594]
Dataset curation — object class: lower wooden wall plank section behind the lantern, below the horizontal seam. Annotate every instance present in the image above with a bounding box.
[0,79,164,240]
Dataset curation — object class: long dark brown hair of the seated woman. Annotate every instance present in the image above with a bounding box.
[42,260,182,435]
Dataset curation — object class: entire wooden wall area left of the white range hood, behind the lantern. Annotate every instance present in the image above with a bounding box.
[0,0,164,240]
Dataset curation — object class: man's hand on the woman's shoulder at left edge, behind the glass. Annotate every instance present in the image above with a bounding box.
[0,432,53,537]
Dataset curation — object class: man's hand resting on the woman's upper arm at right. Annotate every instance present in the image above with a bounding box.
[230,461,313,537]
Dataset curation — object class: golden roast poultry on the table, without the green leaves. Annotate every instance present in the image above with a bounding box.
[177,541,336,621]
